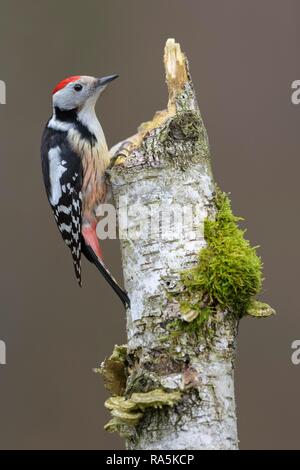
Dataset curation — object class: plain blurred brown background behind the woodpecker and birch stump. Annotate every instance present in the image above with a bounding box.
[0,0,300,449]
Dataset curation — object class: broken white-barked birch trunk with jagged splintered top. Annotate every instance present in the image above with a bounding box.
[106,40,238,450]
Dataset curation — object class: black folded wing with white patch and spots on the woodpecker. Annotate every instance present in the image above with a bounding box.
[41,128,82,285]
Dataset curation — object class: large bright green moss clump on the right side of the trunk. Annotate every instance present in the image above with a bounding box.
[175,190,274,331]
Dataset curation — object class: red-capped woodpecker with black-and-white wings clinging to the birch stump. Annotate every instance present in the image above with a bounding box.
[41,75,130,307]
